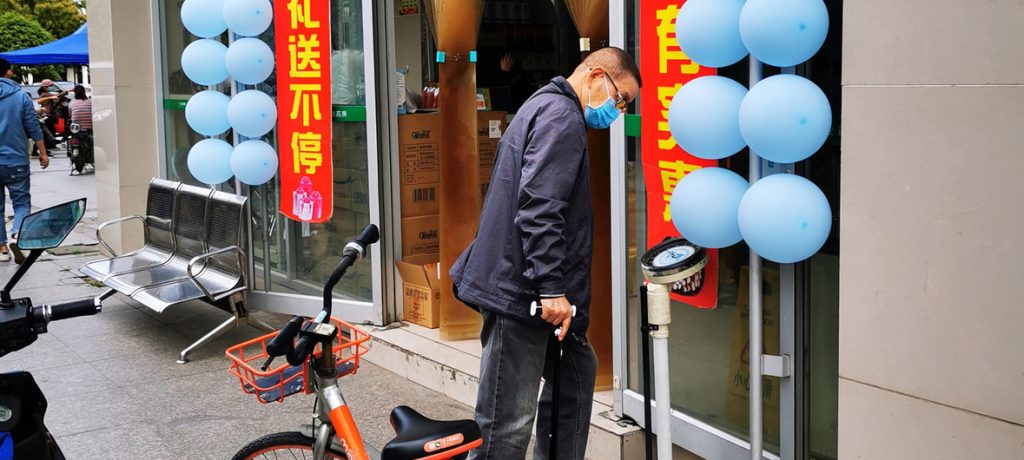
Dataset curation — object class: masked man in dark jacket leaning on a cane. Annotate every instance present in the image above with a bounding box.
[450,48,641,460]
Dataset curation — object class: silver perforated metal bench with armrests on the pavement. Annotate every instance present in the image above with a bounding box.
[80,179,274,364]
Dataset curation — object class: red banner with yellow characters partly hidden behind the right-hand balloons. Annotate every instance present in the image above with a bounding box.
[640,0,718,308]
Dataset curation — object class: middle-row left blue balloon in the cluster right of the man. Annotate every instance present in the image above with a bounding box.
[669,76,746,160]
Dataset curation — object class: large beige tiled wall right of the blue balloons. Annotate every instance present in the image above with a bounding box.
[839,0,1024,459]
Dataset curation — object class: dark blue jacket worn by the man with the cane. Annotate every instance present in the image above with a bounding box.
[450,77,594,332]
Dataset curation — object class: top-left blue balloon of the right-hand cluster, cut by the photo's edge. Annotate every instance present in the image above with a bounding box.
[676,0,748,68]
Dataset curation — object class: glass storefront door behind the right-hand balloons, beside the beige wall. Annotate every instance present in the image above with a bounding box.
[609,0,842,459]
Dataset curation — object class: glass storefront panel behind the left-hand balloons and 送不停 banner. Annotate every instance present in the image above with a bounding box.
[159,0,384,324]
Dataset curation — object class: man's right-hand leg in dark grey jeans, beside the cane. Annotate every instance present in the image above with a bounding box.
[534,334,597,460]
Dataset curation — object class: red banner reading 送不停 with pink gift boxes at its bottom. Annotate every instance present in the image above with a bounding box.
[273,0,334,222]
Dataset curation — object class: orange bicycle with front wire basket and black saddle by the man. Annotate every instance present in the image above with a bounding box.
[226,224,483,460]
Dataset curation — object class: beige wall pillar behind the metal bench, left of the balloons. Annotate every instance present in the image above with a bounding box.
[87,0,159,250]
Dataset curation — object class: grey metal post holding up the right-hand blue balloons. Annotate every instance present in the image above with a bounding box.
[748,54,764,460]
